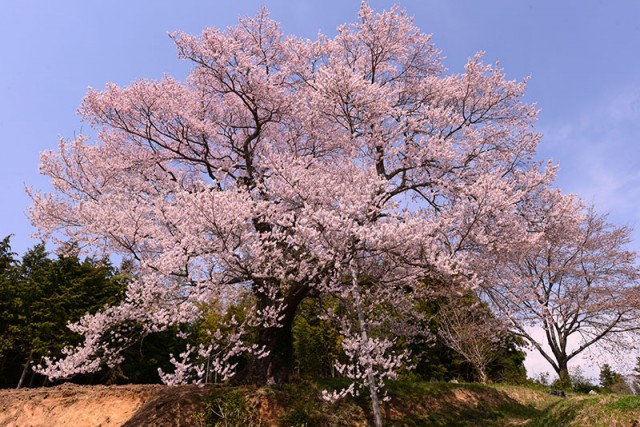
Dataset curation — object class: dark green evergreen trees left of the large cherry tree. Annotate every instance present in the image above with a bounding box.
[0,239,124,387]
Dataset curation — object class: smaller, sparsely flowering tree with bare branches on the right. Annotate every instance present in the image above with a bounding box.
[484,201,640,382]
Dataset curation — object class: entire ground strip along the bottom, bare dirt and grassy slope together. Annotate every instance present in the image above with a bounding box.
[0,383,640,427]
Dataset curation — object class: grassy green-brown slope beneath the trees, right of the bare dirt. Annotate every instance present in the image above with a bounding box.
[202,382,640,427]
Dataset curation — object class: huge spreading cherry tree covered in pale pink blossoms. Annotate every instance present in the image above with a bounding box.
[31,3,553,408]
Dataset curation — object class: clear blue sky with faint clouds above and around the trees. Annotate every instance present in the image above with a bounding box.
[0,0,640,380]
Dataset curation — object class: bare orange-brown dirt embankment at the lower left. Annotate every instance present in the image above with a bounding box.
[0,384,207,427]
